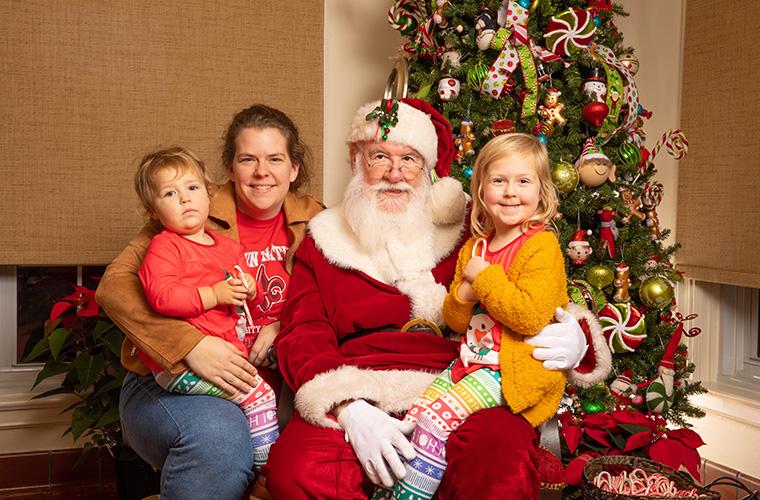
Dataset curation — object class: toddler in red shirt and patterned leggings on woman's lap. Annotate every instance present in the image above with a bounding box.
[135,147,279,470]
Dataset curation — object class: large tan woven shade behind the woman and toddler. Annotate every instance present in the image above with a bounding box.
[0,0,323,264]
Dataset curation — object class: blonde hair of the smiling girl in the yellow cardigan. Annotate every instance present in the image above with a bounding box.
[470,134,559,238]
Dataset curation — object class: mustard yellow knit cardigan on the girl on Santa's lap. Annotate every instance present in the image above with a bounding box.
[443,231,568,427]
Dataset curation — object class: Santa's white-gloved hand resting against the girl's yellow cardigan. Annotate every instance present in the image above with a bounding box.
[525,307,588,370]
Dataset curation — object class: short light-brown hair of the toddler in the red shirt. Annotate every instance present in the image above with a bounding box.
[135,146,212,214]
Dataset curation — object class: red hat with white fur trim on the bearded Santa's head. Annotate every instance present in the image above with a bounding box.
[346,98,455,177]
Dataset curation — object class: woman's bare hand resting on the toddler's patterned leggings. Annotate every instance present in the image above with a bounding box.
[185,336,256,394]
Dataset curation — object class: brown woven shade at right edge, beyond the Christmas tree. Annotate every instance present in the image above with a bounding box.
[676,0,760,288]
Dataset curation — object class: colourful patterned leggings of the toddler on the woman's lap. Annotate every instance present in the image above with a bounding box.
[153,370,280,471]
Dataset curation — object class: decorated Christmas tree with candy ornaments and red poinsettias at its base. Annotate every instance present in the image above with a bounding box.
[387,0,705,492]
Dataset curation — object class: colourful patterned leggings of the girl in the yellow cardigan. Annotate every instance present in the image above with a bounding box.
[373,360,506,499]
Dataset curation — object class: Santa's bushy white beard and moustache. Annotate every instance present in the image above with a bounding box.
[343,171,433,251]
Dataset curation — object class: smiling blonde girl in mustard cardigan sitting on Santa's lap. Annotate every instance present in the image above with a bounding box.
[393,134,568,498]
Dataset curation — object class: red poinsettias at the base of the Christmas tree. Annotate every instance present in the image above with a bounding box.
[558,409,705,485]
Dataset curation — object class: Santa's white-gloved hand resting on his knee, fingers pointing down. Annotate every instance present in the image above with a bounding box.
[338,399,417,488]
